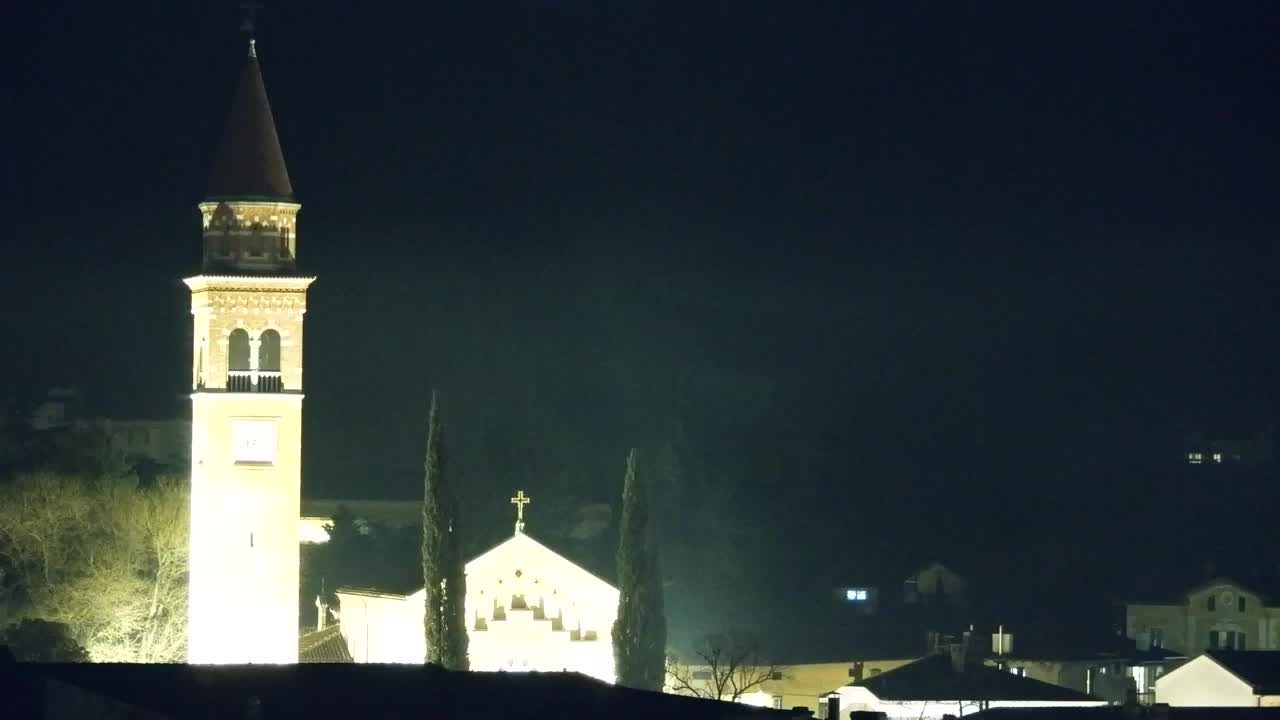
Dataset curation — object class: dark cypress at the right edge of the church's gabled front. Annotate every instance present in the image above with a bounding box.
[613,448,667,691]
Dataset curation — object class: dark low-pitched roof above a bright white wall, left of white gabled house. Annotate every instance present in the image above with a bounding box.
[851,655,1096,702]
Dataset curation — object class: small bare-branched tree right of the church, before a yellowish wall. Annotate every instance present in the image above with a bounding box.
[667,630,785,702]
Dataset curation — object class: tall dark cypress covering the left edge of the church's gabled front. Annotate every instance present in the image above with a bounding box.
[422,389,467,670]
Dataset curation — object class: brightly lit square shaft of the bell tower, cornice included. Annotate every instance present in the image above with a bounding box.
[186,277,311,664]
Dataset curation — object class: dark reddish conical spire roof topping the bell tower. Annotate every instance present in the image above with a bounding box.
[209,40,293,201]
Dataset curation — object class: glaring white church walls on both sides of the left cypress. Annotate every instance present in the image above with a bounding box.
[337,509,618,683]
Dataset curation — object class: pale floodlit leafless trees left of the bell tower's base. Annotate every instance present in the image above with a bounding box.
[0,474,189,662]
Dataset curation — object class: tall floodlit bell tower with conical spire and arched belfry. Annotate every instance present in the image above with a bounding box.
[184,33,315,664]
